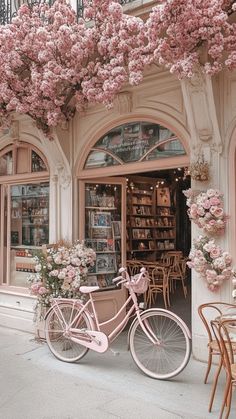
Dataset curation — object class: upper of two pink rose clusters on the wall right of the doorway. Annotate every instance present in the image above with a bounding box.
[183,188,227,235]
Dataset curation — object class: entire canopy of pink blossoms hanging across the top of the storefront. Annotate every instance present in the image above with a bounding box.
[0,0,236,137]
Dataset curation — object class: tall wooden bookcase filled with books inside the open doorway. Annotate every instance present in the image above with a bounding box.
[126,176,176,260]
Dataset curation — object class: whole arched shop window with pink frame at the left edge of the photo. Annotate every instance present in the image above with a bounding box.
[0,141,50,289]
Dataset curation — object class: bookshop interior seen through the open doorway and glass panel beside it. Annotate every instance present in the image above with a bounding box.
[85,168,191,326]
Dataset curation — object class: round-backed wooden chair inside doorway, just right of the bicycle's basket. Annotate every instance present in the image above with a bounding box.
[147,266,170,309]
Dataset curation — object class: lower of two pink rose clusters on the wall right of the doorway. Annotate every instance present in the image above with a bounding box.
[187,236,233,291]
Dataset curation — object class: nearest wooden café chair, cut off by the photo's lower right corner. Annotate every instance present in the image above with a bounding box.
[211,318,236,419]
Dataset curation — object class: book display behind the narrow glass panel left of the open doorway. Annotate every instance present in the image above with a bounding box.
[85,184,121,290]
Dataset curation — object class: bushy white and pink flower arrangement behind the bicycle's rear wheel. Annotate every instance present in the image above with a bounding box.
[28,242,96,318]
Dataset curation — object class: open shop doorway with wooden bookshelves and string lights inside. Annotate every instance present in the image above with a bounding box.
[126,168,191,327]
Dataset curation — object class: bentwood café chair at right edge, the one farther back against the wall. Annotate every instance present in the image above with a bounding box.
[198,302,236,412]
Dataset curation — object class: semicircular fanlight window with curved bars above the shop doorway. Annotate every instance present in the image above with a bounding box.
[85,122,186,169]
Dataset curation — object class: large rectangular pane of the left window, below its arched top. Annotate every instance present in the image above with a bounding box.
[10,182,49,287]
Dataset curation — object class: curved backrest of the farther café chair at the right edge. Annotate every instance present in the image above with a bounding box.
[198,302,236,342]
